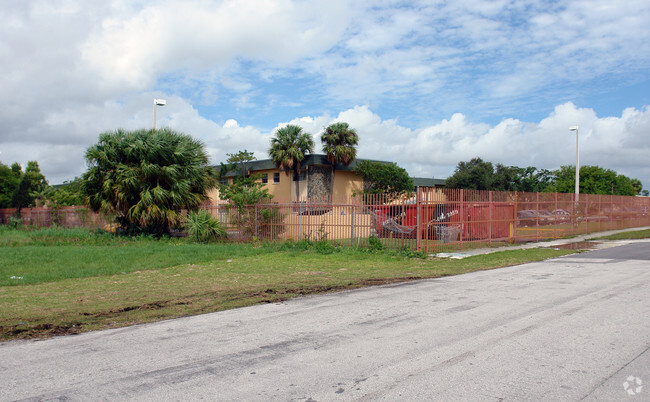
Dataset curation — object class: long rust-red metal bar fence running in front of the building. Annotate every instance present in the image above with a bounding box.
[0,188,650,253]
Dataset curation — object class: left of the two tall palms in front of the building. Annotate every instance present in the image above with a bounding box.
[269,124,314,203]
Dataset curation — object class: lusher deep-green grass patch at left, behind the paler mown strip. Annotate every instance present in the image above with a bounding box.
[0,229,274,286]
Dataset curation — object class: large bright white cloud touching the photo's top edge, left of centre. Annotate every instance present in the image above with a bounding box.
[82,0,348,89]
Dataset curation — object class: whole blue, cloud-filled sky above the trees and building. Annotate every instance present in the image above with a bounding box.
[0,0,650,189]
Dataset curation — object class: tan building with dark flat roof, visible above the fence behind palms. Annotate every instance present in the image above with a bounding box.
[209,154,445,204]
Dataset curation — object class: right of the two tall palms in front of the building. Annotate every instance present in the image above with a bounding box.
[320,122,359,199]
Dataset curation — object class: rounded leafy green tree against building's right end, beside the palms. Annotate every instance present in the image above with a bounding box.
[355,161,414,201]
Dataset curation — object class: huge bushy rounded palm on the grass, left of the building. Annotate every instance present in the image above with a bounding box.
[81,129,214,235]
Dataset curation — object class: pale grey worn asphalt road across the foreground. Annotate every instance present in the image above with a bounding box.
[0,241,650,401]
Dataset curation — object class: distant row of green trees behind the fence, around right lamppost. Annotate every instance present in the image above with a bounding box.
[445,158,648,196]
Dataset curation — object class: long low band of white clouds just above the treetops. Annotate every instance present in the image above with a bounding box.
[0,99,650,186]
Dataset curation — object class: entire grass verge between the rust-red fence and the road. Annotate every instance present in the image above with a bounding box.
[0,228,574,340]
